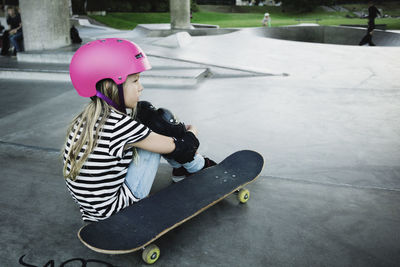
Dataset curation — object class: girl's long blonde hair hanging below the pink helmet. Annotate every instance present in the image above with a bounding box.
[63,79,136,181]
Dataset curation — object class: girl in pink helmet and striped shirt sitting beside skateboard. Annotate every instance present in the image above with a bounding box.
[63,38,215,221]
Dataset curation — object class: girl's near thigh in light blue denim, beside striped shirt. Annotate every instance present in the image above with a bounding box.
[125,148,161,199]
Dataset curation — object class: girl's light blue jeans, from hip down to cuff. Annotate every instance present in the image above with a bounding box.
[125,148,204,199]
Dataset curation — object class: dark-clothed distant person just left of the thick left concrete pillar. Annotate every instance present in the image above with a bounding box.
[7,6,23,55]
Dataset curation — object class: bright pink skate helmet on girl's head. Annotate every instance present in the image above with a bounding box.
[69,38,151,97]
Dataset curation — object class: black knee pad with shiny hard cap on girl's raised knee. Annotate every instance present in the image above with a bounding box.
[136,101,187,138]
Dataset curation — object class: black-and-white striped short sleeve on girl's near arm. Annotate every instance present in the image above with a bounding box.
[109,116,151,158]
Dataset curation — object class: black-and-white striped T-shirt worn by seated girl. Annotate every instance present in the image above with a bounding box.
[64,110,151,221]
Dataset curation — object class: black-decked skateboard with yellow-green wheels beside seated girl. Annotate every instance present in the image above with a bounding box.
[78,150,264,264]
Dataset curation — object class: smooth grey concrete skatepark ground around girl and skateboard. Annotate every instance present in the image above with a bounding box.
[0,21,400,266]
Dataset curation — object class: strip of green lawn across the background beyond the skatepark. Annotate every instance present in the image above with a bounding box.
[91,4,400,30]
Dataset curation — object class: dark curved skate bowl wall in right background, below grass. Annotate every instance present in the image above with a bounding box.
[251,26,400,46]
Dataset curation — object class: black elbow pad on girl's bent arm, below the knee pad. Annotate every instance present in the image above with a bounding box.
[164,131,200,164]
